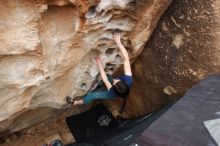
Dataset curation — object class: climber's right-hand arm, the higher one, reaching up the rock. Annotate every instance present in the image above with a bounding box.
[113,33,132,76]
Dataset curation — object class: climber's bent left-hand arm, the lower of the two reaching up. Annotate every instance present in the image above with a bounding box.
[96,56,112,90]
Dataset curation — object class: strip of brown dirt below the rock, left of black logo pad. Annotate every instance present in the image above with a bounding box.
[0,106,85,146]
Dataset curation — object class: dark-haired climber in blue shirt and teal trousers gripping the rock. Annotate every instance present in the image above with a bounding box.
[66,33,133,105]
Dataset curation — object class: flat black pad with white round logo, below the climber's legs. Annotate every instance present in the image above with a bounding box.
[66,105,118,142]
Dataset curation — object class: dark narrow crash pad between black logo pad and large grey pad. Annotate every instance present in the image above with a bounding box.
[65,104,172,146]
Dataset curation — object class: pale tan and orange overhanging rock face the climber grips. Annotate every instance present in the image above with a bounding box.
[0,0,171,132]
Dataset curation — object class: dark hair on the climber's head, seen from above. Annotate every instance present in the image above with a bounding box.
[113,80,130,98]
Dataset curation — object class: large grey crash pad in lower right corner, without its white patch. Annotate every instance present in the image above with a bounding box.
[135,75,220,146]
